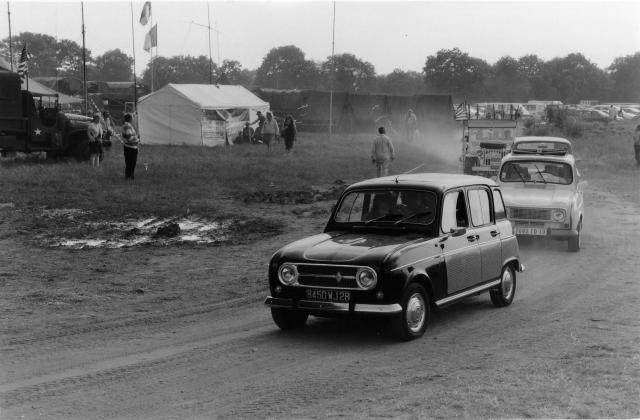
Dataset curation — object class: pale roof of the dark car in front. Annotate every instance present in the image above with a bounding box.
[347,173,498,191]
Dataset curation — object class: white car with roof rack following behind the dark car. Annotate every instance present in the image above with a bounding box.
[497,136,584,252]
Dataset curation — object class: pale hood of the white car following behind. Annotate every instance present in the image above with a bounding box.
[501,184,575,208]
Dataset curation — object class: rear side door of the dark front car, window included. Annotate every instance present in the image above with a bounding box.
[467,187,502,282]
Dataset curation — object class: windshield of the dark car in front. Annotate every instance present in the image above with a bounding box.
[334,188,437,225]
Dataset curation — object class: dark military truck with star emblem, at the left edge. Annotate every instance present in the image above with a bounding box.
[0,71,91,160]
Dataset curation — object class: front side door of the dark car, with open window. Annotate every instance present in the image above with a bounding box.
[440,189,482,295]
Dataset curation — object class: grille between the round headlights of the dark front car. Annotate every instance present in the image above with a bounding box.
[296,264,360,289]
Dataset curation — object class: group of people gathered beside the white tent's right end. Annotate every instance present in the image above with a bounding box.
[242,111,298,153]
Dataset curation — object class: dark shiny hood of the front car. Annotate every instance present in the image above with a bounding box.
[282,231,426,265]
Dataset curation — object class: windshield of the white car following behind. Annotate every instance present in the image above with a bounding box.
[500,160,573,185]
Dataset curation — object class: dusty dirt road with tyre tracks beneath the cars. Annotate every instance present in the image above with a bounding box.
[0,186,640,419]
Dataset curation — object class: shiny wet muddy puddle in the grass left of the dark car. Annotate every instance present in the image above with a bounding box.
[44,217,234,249]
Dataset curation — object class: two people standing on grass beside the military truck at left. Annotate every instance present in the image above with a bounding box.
[87,111,140,180]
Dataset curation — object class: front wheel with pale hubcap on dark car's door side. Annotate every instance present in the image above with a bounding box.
[392,283,431,341]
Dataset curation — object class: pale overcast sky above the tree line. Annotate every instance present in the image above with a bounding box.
[5,0,640,74]
